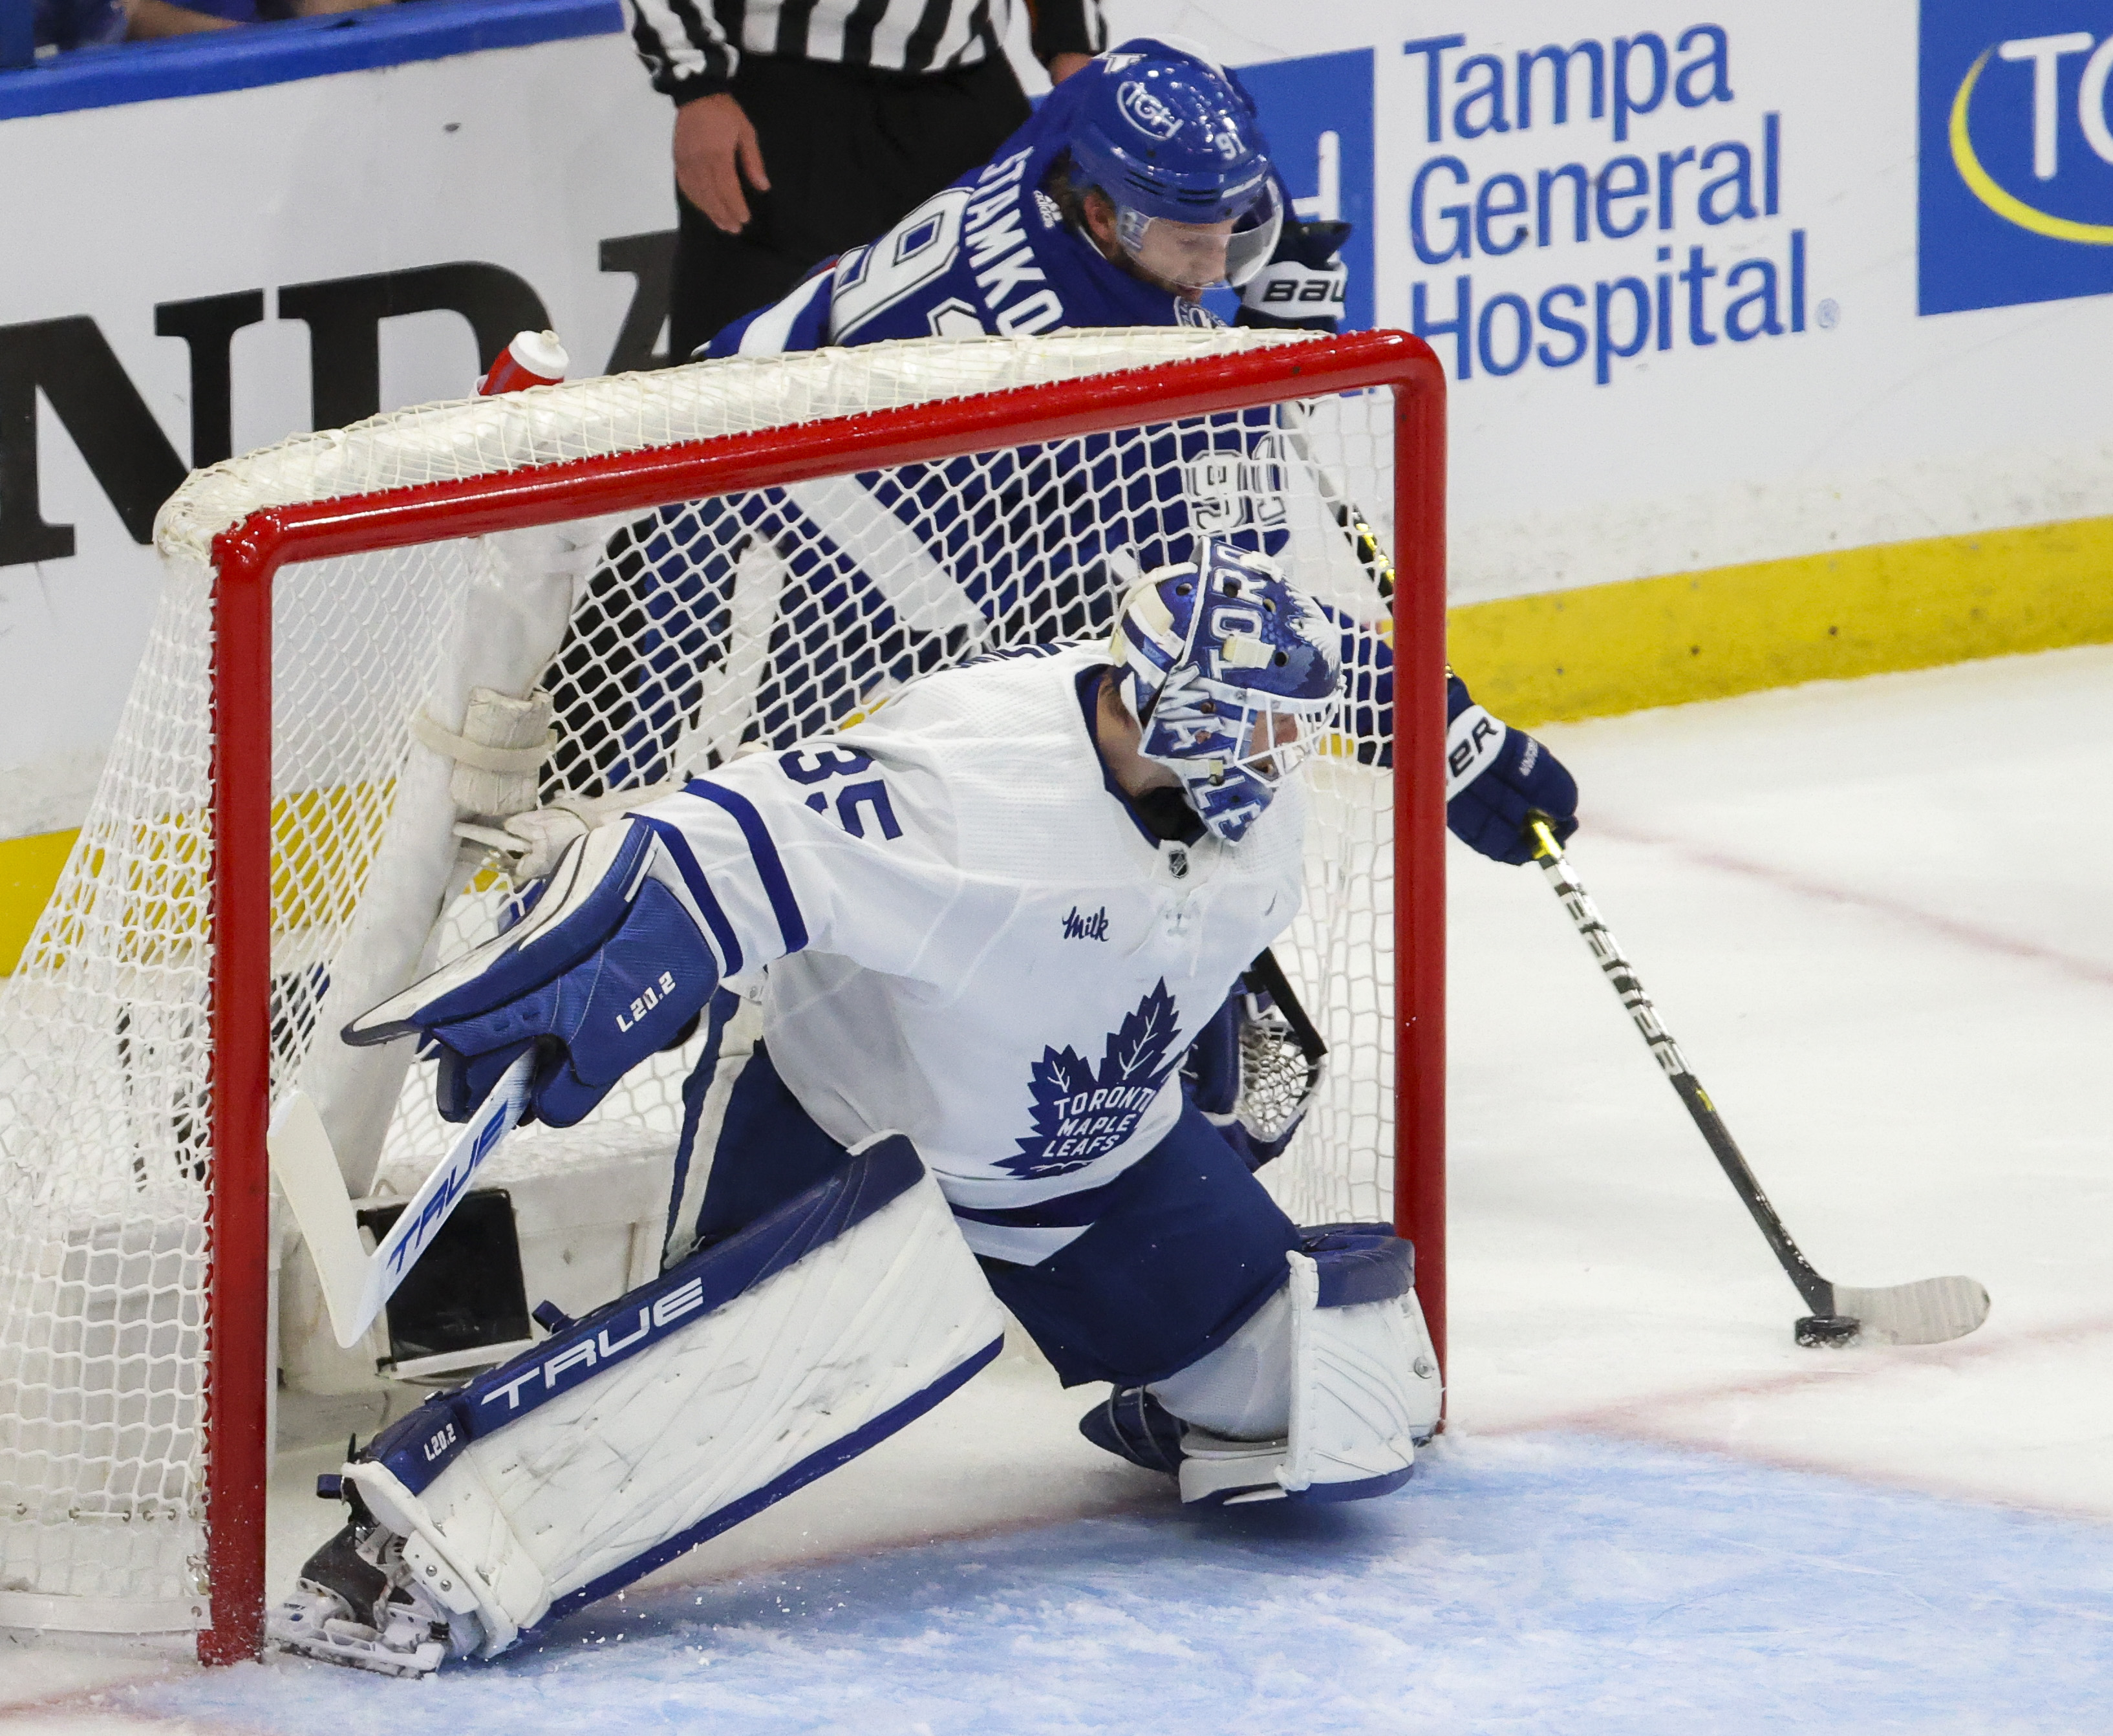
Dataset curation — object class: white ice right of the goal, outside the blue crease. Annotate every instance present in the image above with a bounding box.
[1450,647,2113,1519]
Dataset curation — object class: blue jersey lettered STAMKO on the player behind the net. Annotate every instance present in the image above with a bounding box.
[574,40,1393,788]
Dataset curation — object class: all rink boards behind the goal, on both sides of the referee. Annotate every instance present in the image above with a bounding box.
[0,0,2113,967]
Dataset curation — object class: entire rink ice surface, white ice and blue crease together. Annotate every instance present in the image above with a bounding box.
[0,648,2113,1736]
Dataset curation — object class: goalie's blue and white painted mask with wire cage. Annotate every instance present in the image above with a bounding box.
[1110,542,1342,845]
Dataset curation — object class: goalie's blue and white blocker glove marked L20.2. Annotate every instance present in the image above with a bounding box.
[345,819,718,1128]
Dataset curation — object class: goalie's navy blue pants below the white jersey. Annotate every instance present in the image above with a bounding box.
[670,1026,1300,1386]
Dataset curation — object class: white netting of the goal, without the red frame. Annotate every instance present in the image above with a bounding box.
[0,330,1395,1626]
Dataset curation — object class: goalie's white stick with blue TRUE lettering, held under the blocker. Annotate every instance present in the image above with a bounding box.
[268,1049,535,1349]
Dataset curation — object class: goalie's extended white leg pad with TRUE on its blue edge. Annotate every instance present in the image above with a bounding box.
[327,1136,1003,1656]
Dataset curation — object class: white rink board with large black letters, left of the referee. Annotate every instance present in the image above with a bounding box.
[0,6,674,837]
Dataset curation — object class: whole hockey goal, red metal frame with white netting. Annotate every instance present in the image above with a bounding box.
[0,327,1445,1662]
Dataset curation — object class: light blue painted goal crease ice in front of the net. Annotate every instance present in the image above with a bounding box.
[33,1436,2113,1736]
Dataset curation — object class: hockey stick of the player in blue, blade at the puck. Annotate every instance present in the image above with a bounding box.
[1528,815,1988,1345]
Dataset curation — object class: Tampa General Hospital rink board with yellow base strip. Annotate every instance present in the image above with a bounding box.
[1124,0,2113,718]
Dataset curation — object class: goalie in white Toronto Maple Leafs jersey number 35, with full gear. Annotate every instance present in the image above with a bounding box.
[270,542,1555,1675]
